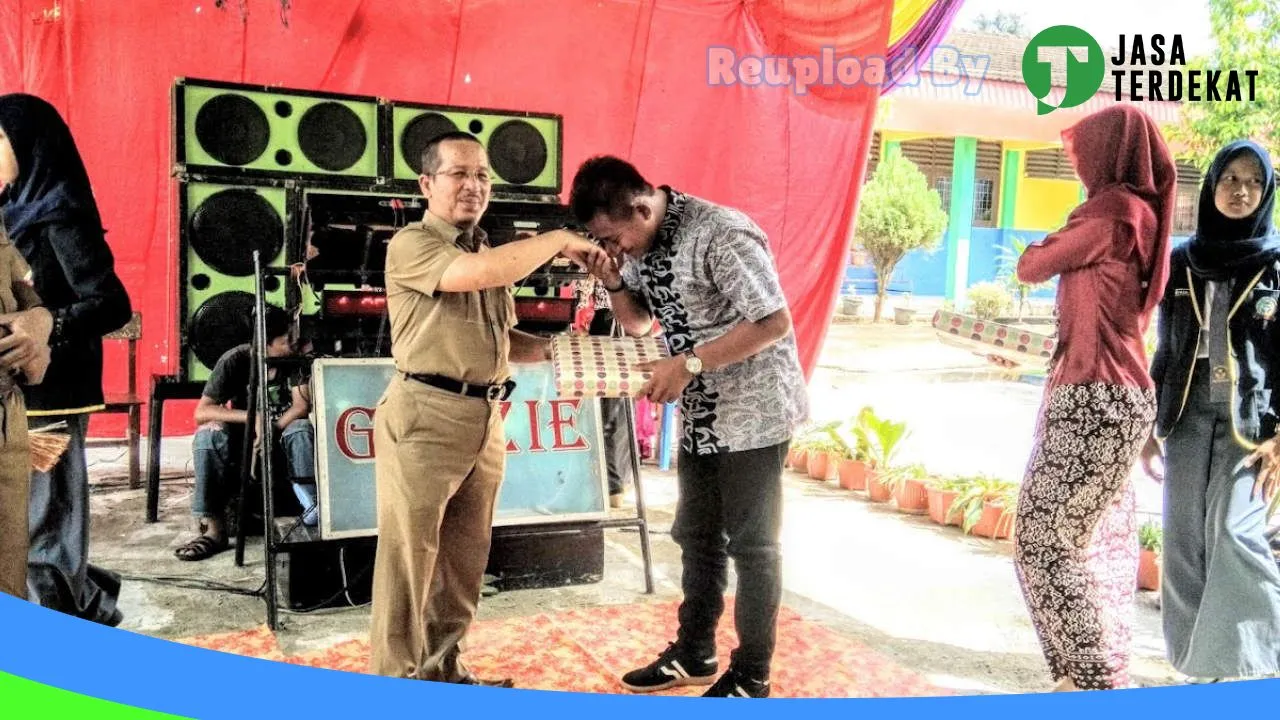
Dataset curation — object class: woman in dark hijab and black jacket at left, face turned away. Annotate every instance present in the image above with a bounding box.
[0,94,132,625]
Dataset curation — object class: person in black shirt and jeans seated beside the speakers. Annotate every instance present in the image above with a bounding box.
[174,307,316,560]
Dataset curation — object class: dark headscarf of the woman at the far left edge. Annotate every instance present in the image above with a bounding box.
[0,94,102,238]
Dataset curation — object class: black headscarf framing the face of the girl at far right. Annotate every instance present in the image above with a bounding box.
[1187,140,1280,281]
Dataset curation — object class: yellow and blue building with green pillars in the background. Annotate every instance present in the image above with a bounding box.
[845,31,1201,304]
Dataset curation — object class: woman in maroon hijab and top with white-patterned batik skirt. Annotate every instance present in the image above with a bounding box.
[1014,105,1176,691]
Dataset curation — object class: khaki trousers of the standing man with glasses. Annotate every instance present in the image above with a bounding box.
[370,375,507,682]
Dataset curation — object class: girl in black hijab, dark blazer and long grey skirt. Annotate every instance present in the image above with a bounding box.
[1144,141,1280,680]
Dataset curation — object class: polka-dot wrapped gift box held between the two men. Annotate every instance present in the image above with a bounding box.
[552,334,667,397]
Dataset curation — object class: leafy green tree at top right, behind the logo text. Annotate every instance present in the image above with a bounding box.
[1167,0,1280,170]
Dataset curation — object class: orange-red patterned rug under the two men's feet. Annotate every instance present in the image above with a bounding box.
[178,598,948,697]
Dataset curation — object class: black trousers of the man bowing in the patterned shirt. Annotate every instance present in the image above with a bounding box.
[671,442,791,680]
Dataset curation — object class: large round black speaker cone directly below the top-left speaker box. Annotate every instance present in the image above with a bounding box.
[191,188,284,277]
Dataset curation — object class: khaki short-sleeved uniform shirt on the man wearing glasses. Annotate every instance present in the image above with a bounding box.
[387,211,516,384]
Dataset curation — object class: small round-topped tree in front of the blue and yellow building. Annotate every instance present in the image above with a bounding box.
[855,151,947,322]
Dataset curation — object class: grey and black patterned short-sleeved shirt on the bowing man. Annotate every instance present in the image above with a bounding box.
[622,187,809,455]
